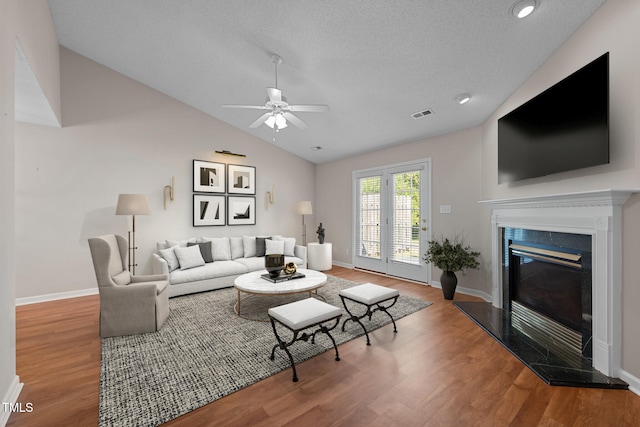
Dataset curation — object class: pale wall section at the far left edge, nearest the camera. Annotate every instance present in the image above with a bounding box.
[0,0,60,425]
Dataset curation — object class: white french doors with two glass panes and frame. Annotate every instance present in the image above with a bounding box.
[353,159,431,282]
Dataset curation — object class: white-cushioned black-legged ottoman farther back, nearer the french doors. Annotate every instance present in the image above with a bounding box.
[339,283,400,345]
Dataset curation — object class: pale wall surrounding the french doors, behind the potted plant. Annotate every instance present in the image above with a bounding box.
[316,128,484,294]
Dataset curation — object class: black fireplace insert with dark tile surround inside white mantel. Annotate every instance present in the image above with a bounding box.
[502,227,592,358]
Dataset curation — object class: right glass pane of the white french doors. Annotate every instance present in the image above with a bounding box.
[390,171,422,264]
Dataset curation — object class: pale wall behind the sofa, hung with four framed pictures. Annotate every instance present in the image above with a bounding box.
[15,48,315,298]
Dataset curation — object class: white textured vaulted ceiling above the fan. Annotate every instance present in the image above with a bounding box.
[49,0,605,163]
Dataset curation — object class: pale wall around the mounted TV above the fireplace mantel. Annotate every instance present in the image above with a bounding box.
[482,0,640,378]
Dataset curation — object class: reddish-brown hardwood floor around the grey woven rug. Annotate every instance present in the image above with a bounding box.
[7,267,640,427]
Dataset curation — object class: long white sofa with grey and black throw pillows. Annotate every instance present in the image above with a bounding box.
[152,235,307,298]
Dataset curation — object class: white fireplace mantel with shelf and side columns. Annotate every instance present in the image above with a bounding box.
[479,190,640,376]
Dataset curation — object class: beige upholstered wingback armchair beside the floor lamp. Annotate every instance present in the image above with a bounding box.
[89,234,169,337]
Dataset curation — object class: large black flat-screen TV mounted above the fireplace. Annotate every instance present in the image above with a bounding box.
[498,53,609,184]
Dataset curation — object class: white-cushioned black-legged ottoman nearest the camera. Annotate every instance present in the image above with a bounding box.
[268,298,342,382]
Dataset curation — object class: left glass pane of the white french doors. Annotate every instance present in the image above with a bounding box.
[357,176,381,259]
